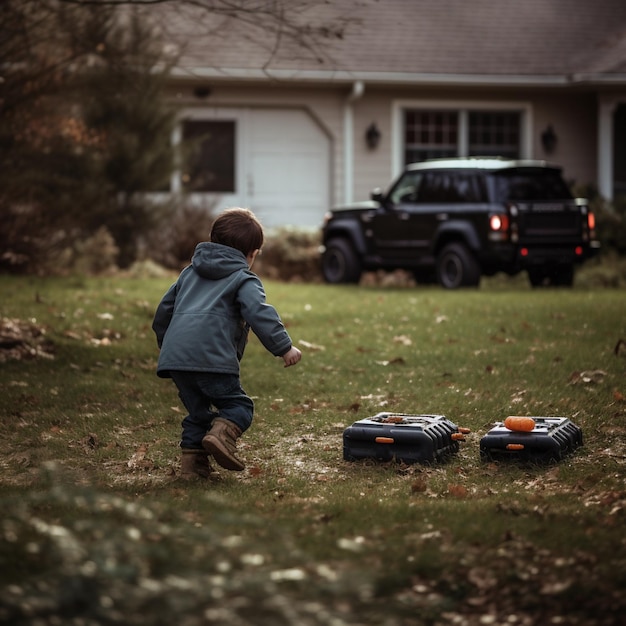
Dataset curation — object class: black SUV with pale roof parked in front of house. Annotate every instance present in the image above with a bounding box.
[322,157,599,289]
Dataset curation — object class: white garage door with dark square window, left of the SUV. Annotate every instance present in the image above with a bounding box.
[178,107,330,228]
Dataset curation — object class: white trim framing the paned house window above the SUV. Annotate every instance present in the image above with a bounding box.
[391,99,533,178]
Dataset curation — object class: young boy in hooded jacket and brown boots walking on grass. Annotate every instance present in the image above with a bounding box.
[152,208,302,478]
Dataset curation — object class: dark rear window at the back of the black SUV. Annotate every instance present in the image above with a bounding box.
[494,169,572,202]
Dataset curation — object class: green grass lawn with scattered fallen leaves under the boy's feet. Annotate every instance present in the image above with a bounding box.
[0,277,626,626]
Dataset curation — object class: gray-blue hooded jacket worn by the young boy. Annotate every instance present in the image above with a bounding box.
[152,242,292,378]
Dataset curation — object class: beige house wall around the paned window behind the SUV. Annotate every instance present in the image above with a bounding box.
[172,84,616,214]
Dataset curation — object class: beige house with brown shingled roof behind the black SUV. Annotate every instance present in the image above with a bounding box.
[157,0,626,227]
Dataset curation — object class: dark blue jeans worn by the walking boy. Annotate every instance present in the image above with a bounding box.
[170,371,254,449]
